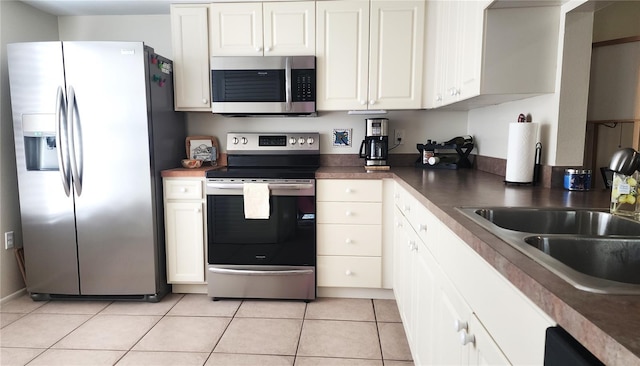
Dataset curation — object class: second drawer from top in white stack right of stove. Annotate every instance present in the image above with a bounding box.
[316,202,382,225]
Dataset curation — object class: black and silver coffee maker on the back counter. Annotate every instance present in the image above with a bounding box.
[360,118,389,166]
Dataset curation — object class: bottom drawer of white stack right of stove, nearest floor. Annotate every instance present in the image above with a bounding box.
[318,256,382,288]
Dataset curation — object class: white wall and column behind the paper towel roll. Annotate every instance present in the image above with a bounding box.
[468,0,593,166]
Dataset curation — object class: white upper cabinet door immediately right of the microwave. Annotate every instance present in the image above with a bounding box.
[316,0,369,110]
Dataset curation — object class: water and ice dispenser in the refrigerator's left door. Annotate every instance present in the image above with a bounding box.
[22,114,58,170]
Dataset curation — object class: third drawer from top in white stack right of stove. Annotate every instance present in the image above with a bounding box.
[316,224,382,257]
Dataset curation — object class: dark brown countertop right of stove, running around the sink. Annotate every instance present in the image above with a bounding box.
[316,167,640,365]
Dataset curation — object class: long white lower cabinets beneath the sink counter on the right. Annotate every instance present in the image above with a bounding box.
[393,184,555,365]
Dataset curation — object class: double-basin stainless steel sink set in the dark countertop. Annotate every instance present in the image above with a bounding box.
[458,207,640,295]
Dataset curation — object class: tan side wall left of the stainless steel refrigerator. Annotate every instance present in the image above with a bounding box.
[0,1,58,301]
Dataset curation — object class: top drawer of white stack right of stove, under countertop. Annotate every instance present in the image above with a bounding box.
[316,179,382,202]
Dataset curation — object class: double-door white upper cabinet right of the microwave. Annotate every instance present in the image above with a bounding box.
[316,0,425,110]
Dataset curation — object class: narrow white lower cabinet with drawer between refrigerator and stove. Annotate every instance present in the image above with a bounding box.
[163,178,206,284]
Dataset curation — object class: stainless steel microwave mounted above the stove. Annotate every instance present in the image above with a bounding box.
[211,56,316,116]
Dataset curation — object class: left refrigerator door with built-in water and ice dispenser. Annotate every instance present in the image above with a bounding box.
[7,42,79,295]
